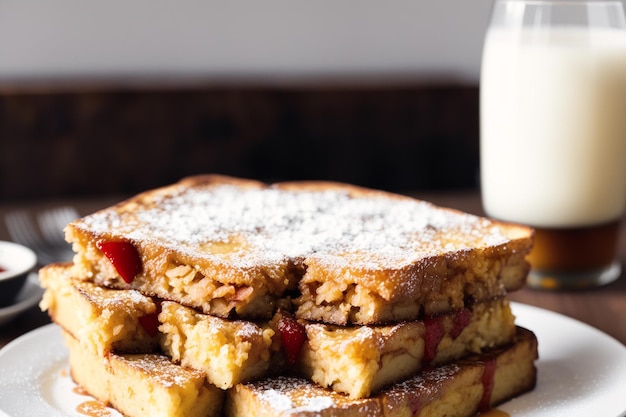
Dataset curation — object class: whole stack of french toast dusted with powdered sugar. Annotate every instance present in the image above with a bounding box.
[39,175,537,417]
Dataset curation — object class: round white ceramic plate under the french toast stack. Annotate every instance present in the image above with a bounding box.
[0,303,626,417]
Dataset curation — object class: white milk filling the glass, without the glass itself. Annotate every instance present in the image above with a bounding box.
[480,29,626,227]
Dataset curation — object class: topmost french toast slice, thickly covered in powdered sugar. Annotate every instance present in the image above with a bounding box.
[66,175,532,325]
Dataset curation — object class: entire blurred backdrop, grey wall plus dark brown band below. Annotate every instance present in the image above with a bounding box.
[0,0,490,200]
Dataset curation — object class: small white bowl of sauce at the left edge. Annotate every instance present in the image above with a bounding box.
[0,241,37,307]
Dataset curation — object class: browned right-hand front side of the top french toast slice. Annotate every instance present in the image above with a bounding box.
[294,245,530,325]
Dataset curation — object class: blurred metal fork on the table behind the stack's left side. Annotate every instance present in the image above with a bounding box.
[4,207,80,265]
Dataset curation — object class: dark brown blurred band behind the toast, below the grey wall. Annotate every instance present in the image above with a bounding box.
[0,85,478,199]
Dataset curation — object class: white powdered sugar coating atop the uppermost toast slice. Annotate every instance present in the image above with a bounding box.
[76,185,508,267]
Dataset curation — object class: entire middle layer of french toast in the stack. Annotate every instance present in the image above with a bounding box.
[40,265,515,398]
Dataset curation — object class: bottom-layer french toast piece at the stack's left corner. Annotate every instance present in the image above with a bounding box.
[63,332,224,417]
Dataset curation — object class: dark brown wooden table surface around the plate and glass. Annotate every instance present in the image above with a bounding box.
[0,191,626,347]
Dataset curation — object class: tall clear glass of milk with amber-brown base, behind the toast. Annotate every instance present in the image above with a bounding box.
[480,0,626,289]
